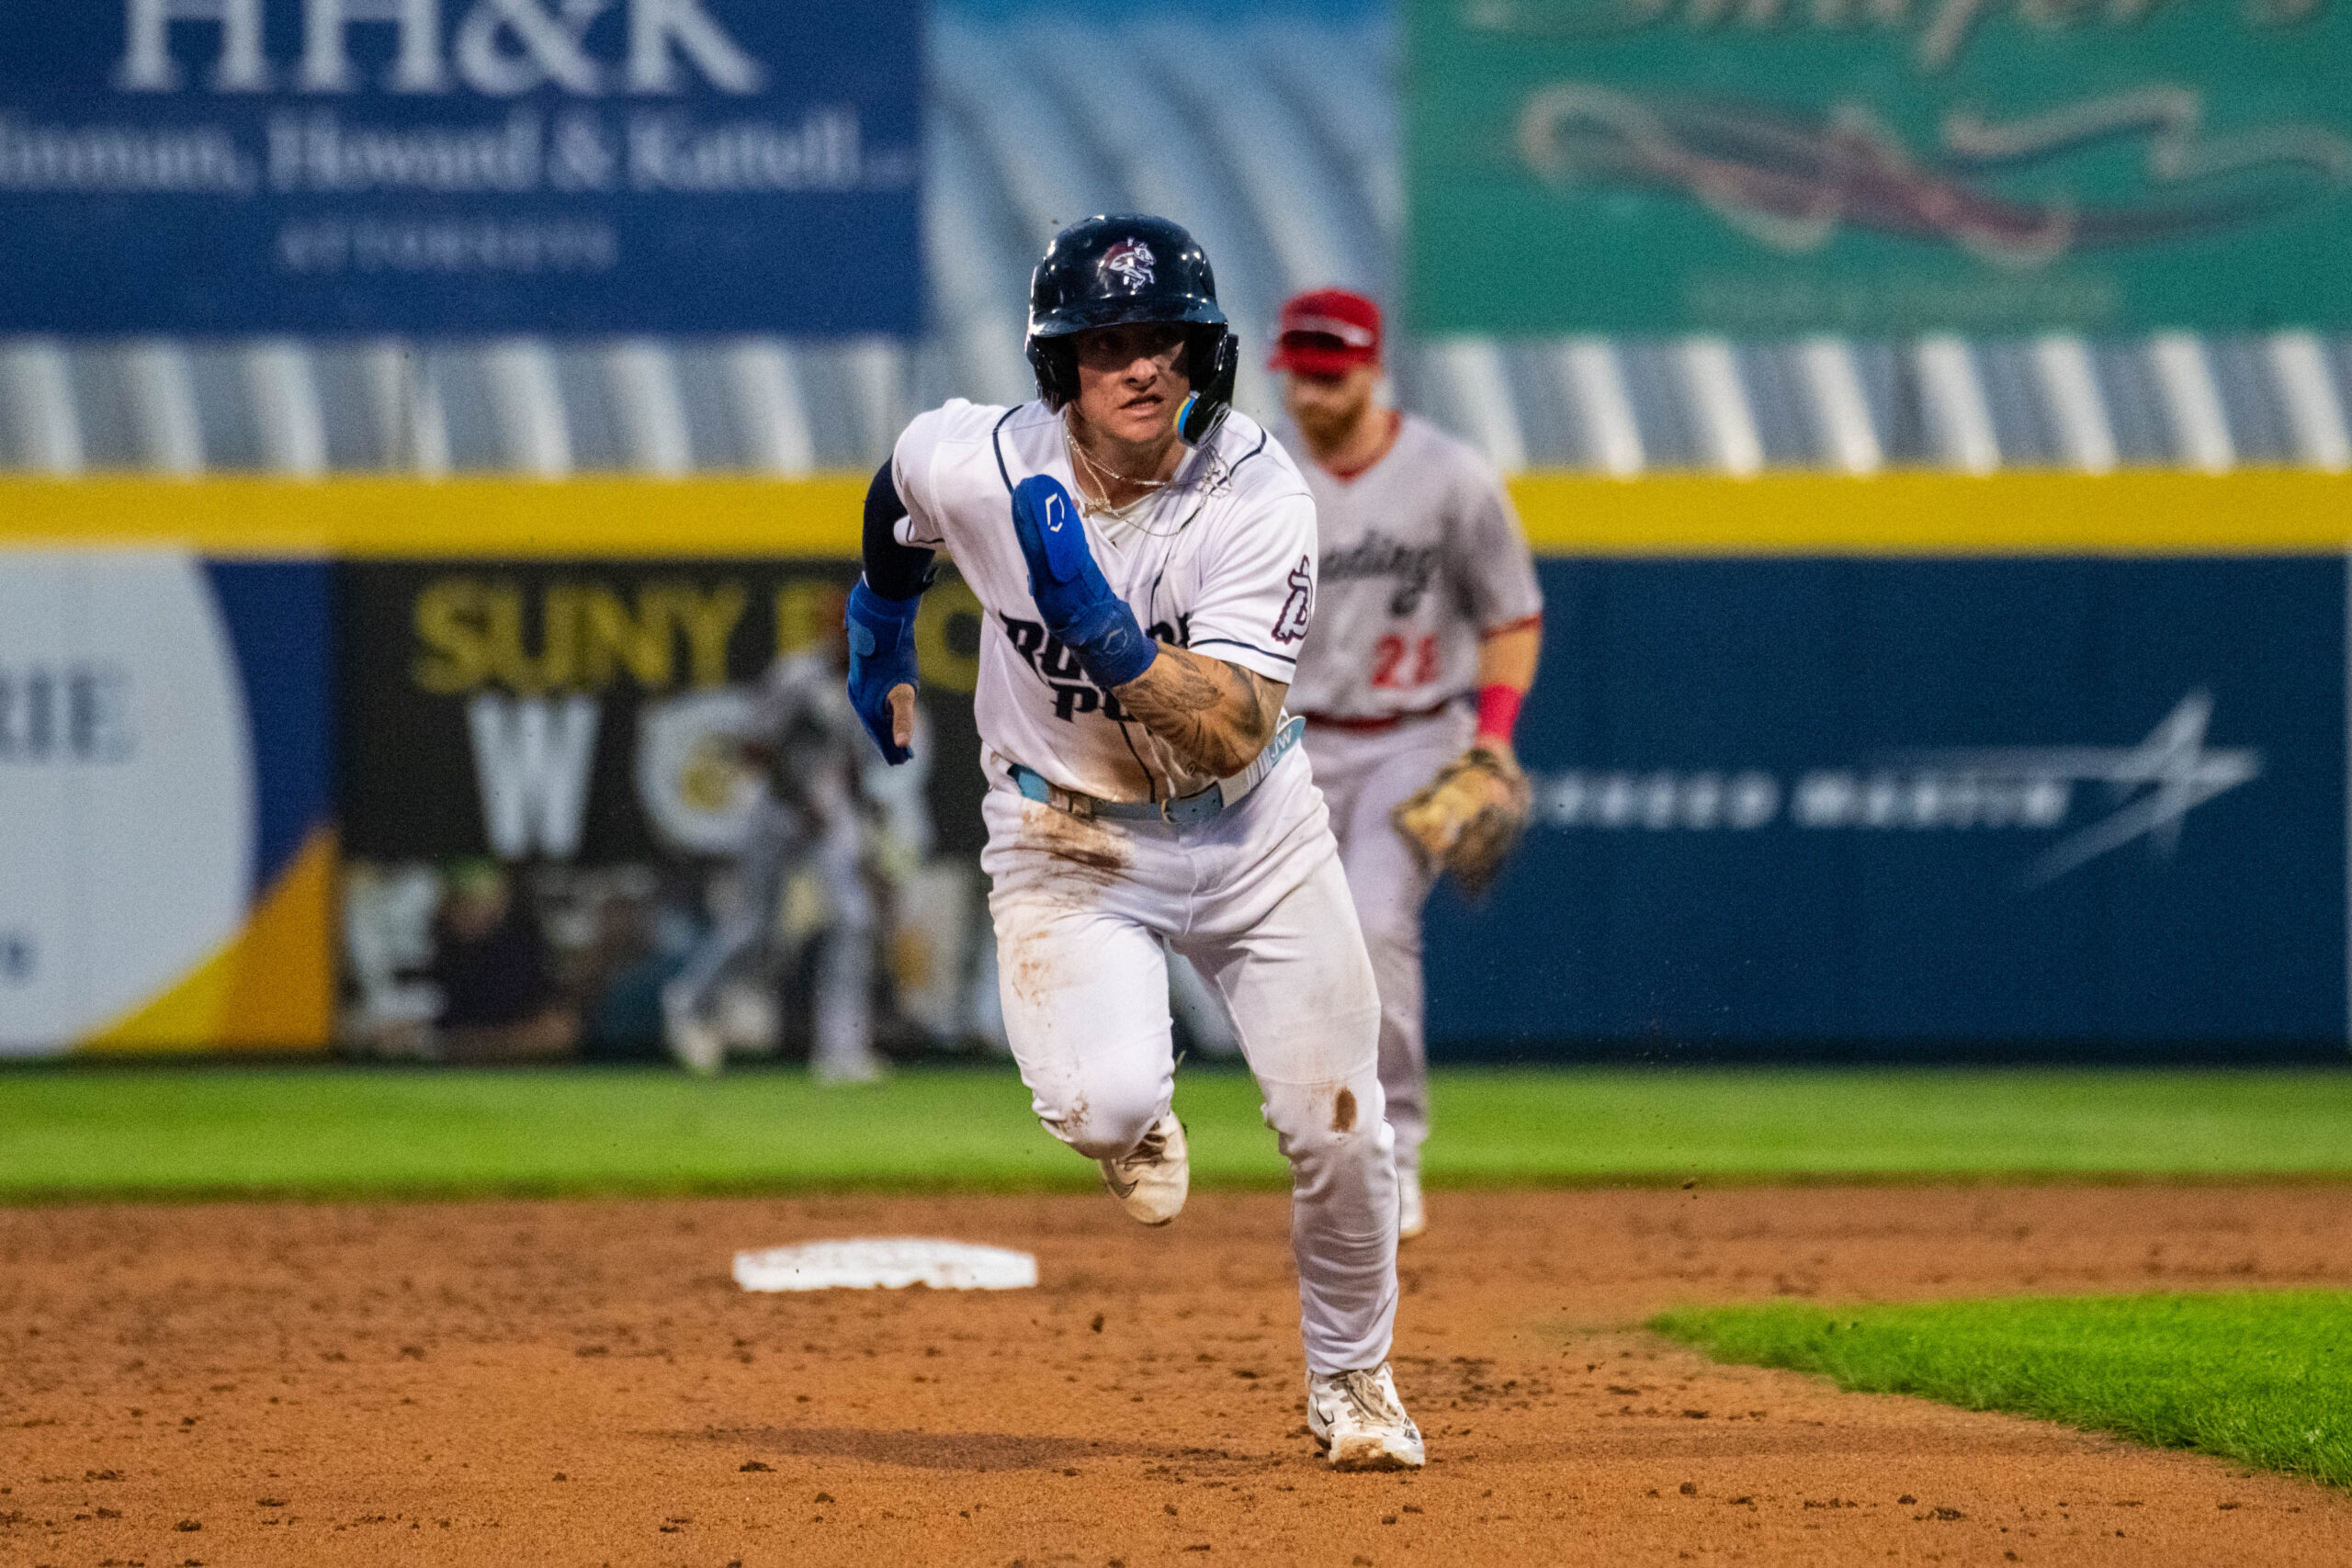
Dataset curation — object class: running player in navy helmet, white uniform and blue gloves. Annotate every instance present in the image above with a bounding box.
[849,216,1423,1470]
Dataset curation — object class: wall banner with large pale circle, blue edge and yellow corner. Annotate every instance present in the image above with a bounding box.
[0,547,336,1058]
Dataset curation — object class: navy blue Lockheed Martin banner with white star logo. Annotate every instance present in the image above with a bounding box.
[1428,558,2347,1055]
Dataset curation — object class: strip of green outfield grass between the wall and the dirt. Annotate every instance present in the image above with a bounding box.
[0,1065,2352,1201]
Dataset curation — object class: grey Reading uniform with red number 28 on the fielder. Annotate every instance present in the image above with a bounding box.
[1289,413,1543,1170]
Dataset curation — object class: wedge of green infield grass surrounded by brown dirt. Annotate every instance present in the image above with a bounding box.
[1651,1291,2352,1485]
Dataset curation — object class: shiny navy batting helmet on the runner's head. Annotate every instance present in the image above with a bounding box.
[1028,214,1242,446]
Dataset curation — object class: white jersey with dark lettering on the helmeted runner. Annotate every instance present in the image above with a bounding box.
[891,398,1315,802]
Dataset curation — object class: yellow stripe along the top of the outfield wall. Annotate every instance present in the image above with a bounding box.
[0,470,2352,559]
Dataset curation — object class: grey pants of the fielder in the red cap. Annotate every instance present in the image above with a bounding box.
[1303,705,1477,1170]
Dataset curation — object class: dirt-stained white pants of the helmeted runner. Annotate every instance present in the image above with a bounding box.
[981,757,1397,1373]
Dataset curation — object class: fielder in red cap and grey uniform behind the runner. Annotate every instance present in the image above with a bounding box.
[1272,289,1543,1239]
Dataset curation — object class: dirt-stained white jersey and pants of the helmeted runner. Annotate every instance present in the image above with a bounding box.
[891,402,1397,1373]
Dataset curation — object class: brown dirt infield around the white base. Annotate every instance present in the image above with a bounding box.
[0,1187,2352,1568]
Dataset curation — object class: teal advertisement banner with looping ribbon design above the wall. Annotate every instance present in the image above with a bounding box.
[1404,0,2352,336]
